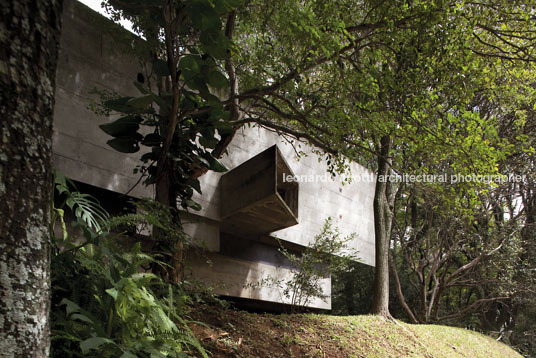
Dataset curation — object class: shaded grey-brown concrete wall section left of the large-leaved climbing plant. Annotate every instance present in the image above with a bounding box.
[53,0,152,197]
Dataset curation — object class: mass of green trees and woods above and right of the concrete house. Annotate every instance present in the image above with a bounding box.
[93,0,536,349]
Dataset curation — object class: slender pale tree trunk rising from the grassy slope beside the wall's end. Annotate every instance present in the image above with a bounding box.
[371,136,392,317]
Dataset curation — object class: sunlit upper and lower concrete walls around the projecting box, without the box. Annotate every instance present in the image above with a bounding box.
[192,127,374,309]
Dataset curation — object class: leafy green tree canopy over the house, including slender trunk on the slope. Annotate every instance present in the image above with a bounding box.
[98,0,535,315]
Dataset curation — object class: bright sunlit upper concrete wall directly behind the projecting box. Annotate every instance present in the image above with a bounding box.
[194,127,374,265]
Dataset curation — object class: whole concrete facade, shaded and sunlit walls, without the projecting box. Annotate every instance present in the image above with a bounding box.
[53,0,374,309]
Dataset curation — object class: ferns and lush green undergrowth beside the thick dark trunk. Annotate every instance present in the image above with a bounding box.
[51,174,207,358]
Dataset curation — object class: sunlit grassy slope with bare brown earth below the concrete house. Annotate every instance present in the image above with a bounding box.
[187,306,521,358]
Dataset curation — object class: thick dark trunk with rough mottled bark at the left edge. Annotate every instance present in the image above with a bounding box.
[0,0,62,358]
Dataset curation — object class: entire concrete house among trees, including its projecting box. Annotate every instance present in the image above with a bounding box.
[53,0,374,309]
